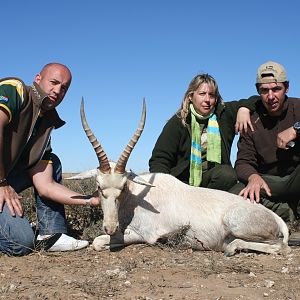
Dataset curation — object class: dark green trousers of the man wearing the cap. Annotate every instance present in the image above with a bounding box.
[229,165,300,222]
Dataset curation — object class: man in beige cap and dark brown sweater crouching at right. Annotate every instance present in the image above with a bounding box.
[231,61,300,241]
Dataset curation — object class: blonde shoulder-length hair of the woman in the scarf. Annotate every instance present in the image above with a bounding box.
[176,73,223,126]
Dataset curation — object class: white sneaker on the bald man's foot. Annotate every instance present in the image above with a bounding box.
[37,233,89,252]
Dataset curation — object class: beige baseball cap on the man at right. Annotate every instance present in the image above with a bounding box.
[256,61,288,83]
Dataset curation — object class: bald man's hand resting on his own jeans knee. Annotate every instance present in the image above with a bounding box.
[0,185,23,217]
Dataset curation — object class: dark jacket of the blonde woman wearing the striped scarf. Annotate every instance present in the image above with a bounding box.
[149,97,258,183]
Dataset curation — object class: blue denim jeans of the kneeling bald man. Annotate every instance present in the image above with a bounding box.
[0,153,67,256]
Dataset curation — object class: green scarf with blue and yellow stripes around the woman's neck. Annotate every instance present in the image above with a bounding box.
[189,103,221,186]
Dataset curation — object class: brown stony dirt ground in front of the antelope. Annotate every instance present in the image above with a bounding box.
[0,245,300,300]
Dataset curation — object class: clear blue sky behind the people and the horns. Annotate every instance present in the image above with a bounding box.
[0,0,300,172]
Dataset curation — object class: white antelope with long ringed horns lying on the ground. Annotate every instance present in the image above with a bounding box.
[69,100,290,256]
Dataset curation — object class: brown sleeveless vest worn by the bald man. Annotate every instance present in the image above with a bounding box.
[1,78,65,176]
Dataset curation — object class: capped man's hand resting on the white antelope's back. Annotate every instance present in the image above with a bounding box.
[239,174,272,203]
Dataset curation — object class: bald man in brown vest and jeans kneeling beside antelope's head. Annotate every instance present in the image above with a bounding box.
[0,63,99,256]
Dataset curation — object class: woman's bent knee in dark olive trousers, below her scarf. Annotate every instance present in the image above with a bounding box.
[200,165,237,191]
